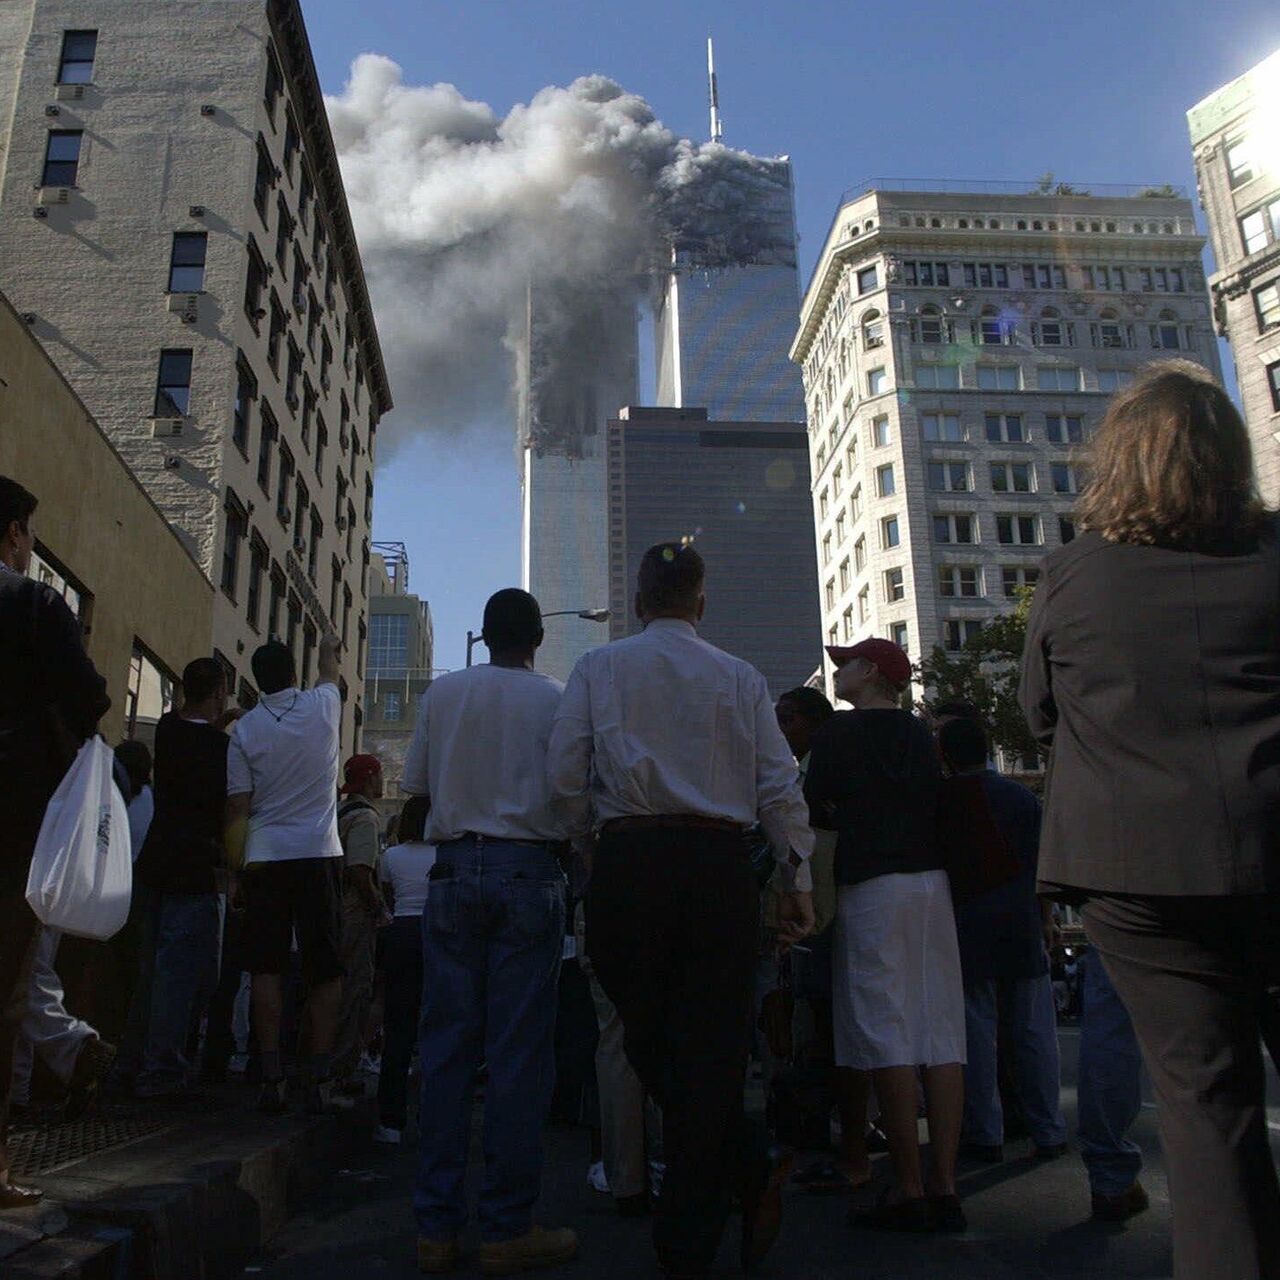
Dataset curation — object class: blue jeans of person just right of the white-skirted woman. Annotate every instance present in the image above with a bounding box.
[964,974,1066,1147]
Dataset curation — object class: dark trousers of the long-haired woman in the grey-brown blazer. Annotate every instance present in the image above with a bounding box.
[1083,893,1280,1280]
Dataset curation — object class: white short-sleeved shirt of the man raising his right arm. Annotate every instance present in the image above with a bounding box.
[227,685,342,863]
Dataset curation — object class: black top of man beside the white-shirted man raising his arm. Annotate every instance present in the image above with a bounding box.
[133,712,230,893]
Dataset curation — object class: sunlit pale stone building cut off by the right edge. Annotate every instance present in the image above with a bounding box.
[1187,51,1280,506]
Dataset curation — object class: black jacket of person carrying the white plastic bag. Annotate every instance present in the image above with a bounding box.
[0,568,111,888]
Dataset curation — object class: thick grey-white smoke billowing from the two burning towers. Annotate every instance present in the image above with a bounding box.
[328,54,795,451]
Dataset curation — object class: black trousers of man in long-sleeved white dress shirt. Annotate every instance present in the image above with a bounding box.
[586,828,764,1271]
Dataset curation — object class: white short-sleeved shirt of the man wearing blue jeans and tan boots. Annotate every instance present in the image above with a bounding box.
[401,664,566,845]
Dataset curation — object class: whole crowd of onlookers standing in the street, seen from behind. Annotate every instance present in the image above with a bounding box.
[0,350,1280,1280]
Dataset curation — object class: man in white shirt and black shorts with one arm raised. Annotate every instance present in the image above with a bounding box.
[227,635,342,1112]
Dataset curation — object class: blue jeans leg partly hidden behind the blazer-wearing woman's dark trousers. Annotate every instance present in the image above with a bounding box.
[1079,947,1142,1196]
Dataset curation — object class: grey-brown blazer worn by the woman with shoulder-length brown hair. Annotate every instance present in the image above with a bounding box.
[1021,526,1280,896]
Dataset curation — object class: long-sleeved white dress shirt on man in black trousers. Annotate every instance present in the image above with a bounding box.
[547,618,813,890]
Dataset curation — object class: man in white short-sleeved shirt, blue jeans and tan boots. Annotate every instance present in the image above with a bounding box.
[401,588,577,1275]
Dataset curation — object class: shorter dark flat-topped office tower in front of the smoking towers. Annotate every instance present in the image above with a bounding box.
[607,406,822,696]
